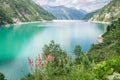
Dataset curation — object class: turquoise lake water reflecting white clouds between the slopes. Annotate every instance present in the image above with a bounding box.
[0,22,107,80]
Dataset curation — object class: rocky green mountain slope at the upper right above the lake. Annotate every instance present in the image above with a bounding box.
[90,0,120,21]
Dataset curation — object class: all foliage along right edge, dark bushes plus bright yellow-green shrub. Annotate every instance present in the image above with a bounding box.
[88,19,120,80]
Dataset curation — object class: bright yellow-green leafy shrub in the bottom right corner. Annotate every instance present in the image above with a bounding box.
[93,53,120,80]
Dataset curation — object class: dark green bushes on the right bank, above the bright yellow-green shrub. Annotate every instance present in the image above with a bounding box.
[88,19,120,62]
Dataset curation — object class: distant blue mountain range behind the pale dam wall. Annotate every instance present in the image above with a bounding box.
[43,6,86,20]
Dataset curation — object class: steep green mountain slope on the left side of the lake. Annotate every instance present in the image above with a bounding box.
[0,0,54,25]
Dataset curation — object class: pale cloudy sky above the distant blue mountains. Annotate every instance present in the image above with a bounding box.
[34,0,110,12]
